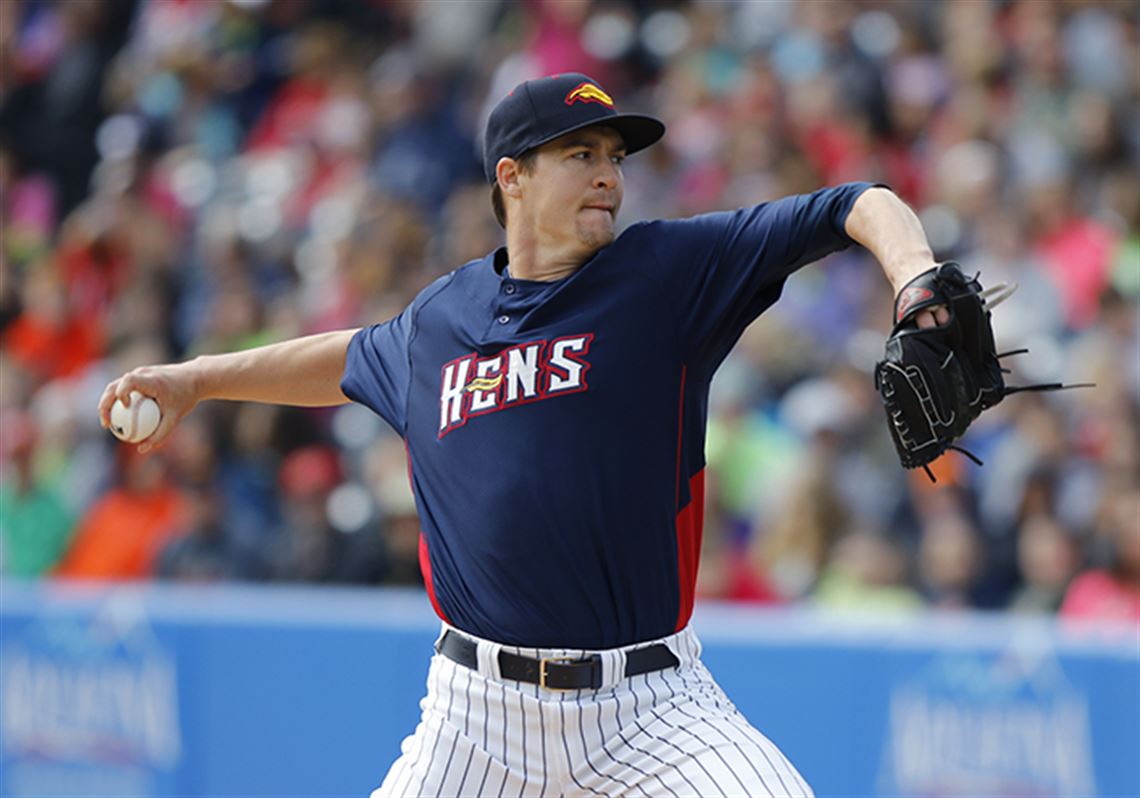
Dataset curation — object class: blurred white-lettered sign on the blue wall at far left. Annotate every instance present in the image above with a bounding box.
[0,600,184,797]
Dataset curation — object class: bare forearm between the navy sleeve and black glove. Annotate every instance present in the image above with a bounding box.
[846,187,935,293]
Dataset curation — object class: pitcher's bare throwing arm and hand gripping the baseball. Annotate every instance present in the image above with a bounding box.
[99,329,358,453]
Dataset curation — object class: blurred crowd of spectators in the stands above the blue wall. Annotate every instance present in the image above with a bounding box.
[0,0,1140,619]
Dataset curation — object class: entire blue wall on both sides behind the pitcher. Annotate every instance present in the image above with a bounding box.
[0,581,1140,798]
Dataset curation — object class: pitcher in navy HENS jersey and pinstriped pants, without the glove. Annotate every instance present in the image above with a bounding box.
[100,74,944,798]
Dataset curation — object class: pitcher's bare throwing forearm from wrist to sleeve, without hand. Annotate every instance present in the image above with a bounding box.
[189,329,356,407]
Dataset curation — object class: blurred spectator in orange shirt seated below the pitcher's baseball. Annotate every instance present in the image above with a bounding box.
[55,446,188,580]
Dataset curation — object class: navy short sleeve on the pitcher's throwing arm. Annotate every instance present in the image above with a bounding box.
[341,306,412,435]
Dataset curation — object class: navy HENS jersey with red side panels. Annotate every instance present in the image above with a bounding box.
[341,184,870,649]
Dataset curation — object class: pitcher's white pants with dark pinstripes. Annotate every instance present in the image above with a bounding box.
[372,626,813,798]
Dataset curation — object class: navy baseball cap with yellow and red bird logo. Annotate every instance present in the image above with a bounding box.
[483,72,665,182]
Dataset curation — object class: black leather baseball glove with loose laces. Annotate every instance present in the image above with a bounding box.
[874,262,1064,480]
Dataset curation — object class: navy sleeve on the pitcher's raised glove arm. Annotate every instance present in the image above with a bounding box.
[642,182,873,359]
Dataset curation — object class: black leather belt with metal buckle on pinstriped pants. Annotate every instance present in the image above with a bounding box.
[435,629,681,690]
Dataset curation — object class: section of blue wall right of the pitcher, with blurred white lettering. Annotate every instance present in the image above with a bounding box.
[695,606,1140,798]
